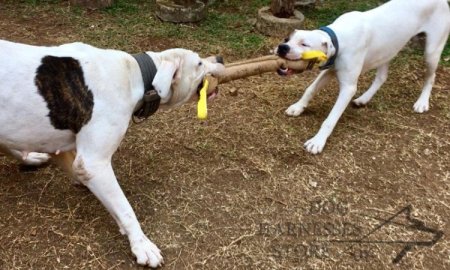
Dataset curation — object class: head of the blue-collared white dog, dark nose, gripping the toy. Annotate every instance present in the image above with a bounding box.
[276,30,335,60]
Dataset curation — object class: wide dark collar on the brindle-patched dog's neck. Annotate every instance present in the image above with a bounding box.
[133,53,161,122]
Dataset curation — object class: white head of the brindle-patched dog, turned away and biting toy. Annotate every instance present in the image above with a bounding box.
[153,49,225,107]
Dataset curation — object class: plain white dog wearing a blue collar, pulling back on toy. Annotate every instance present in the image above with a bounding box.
[277,0,450,154]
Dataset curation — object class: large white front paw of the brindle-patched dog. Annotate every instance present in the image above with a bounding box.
[131,235,164,268]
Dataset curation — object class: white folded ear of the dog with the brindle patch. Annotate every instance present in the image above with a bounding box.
[152,60,181,100]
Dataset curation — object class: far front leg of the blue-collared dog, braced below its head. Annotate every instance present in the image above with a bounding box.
[285,69,335,116]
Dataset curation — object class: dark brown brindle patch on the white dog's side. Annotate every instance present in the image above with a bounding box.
[35,56,94,133]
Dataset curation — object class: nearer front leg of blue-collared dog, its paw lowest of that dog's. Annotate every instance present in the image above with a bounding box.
[304,73,358,154]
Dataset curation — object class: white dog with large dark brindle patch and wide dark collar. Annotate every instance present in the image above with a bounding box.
[0,40,224,267]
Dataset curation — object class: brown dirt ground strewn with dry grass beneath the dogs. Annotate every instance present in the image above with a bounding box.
[0,1,450,269]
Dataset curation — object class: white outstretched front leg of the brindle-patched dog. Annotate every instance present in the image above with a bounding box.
[73,151,163,267]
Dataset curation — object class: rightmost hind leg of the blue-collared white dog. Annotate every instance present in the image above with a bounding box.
[414,25,448,113]
